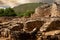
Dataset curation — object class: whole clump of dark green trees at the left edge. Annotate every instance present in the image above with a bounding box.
[0,8,16,16]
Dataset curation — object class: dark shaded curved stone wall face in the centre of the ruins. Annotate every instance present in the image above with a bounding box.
[26,20,44,31]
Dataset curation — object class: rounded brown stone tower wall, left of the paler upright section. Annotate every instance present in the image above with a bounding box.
[31,4,51,18]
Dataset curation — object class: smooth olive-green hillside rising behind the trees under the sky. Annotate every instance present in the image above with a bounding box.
[14,3,43,13]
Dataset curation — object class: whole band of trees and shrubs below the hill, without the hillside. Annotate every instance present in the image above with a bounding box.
[0,8,34,17]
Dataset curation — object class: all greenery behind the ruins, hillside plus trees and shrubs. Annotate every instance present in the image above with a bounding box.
[0,3,43,17]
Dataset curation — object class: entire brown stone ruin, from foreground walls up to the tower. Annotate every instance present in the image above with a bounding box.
[0,3,60,40]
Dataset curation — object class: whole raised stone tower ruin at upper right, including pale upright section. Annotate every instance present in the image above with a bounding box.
[31,3,60,18]
